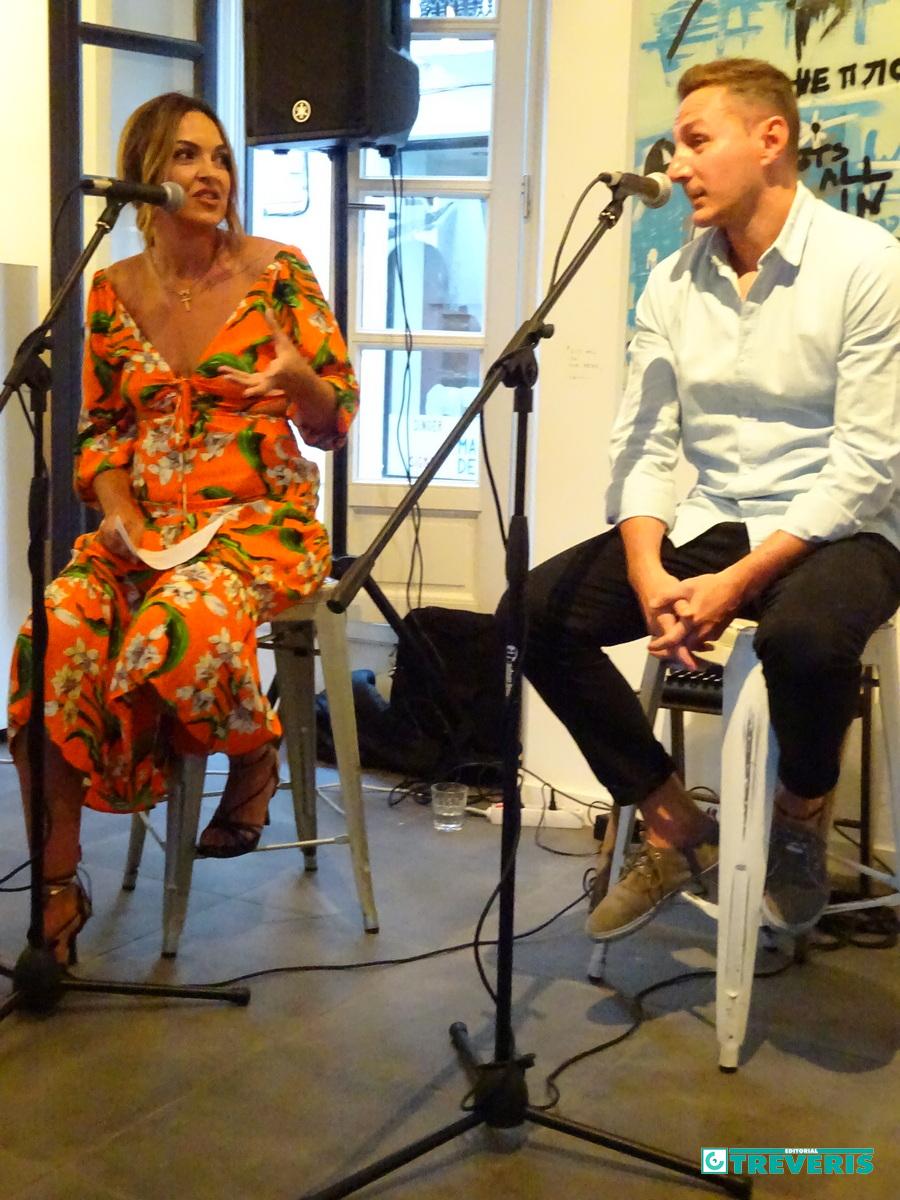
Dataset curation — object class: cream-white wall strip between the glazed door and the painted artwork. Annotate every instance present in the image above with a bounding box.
[524,0,642,798]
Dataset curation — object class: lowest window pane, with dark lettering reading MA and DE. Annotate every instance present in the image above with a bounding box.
[356,349,481,486]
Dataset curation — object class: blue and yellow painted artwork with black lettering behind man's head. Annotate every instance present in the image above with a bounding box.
[630,0,900,324]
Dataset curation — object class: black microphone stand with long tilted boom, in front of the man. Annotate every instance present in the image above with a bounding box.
[304,187,751,1200]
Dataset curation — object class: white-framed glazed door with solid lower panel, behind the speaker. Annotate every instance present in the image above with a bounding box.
[243,0,532,619]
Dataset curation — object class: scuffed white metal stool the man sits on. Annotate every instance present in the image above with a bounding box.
[588,619,900,1070]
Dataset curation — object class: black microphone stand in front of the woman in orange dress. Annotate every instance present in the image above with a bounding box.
[0,198,250,1020]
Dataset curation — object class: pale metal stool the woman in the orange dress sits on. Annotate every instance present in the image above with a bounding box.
[122,582,378,958]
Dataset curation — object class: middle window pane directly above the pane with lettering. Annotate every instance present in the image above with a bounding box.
[360,196,487,332]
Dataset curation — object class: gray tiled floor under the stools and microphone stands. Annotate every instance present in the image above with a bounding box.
[0,753,900,1200]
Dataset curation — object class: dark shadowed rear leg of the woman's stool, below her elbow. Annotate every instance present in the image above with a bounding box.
[275,620,318,871]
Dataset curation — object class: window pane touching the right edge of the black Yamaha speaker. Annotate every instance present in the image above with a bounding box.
[361,37,494,179]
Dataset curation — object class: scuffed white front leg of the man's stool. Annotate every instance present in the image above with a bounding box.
[715,630,775,1070]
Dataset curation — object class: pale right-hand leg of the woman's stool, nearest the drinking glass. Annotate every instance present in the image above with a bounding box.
[316,604,378,934]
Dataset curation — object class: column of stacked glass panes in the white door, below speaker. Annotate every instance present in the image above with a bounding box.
[349,8,498,487]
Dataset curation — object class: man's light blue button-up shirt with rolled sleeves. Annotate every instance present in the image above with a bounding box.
[607,184,900,548]
